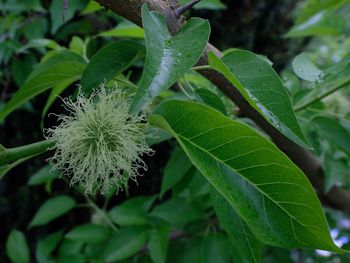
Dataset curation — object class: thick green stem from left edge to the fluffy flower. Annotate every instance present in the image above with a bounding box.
[0,140,54,165]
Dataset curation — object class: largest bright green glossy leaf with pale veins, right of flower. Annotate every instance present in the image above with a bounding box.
[149,100,342,252]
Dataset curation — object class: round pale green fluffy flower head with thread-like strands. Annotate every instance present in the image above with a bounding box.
[46,87,152,193]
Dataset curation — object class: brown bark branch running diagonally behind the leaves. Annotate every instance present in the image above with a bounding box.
[96,0,350,211]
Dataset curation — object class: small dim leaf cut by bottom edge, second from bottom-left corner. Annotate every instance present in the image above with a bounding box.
[35,232,62,263]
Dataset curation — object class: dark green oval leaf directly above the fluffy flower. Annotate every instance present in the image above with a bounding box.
[80,40,144,94]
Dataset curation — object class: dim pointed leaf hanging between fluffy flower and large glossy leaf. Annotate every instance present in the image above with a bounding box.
[160,147,192,197]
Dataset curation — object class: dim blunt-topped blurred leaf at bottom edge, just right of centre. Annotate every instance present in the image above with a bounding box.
[201,234,231,263]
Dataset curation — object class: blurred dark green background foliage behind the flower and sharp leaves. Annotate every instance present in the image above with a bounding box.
[0,0,350,262]
